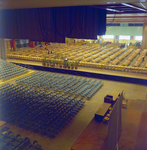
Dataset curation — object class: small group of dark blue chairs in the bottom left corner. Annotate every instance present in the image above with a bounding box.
[0,127,42,150]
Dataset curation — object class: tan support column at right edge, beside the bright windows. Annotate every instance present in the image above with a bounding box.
[141,23,147,50]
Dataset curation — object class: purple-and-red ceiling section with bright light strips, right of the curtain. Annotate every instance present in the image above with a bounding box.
[102,2,147,23]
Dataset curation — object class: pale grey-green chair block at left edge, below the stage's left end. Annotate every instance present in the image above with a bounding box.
[0,59,28,80]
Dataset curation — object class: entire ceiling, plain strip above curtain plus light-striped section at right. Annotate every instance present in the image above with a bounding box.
[0,0,147,22]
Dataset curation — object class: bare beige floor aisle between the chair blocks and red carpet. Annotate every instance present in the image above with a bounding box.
[1,60,147,150]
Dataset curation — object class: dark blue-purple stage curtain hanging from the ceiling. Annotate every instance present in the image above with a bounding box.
[0,6,106,42]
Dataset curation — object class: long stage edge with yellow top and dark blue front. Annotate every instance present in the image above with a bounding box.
[7,59,147,85]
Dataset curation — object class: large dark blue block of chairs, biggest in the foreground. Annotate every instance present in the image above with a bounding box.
[0,84,85,137]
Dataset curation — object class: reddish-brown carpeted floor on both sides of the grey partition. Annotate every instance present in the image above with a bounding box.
[72,100,147,150]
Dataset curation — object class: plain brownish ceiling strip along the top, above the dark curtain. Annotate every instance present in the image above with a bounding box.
[0,0,147,9]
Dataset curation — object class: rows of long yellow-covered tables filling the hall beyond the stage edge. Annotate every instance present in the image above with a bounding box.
[7,44,147,73]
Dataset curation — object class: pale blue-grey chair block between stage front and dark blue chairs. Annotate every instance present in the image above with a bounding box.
[16,71,103,98]
